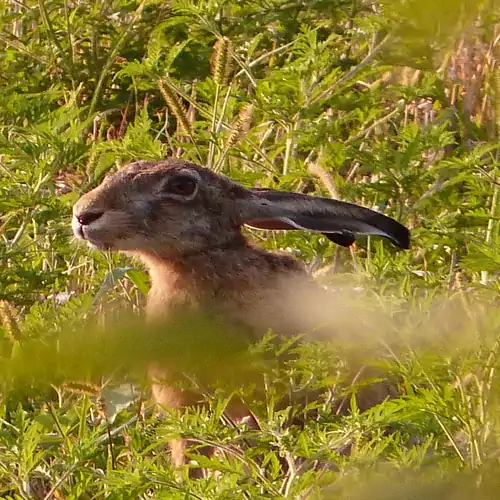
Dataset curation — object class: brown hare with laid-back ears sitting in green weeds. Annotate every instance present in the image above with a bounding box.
[72,160,410,474]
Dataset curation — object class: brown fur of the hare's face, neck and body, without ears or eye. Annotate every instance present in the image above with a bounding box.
[73,160,404,474]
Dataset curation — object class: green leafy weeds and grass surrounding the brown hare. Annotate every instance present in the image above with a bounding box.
[0,0,500,499]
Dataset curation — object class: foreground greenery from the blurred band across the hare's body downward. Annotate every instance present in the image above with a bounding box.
[0,290,500,499]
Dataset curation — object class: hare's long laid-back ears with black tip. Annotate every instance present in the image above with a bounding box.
[240,189,410,249]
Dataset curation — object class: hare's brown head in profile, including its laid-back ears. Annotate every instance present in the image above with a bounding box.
[72,160,410,259]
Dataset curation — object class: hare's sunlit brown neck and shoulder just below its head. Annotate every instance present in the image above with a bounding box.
[134,242,304,324]
